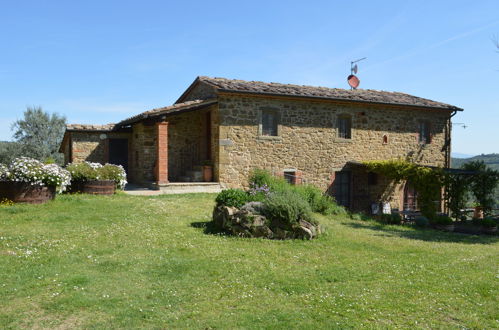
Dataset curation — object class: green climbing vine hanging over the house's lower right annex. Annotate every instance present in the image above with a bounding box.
[365,160,444,218]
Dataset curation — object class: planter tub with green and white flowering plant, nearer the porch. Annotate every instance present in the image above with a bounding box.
[66,162,127,195]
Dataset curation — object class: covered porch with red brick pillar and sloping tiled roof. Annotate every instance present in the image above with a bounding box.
[120,100,220,193]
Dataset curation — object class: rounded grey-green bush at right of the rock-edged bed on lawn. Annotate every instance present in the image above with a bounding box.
[263,190,313,226]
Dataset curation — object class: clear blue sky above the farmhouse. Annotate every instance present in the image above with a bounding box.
[0,0,499,154]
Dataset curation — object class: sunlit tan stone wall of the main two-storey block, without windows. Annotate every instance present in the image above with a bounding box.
[218,95,450,210]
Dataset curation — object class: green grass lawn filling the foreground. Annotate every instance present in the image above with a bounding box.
[0,194,499,328]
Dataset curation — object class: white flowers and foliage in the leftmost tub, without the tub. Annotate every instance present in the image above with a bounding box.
[0,157,71,193]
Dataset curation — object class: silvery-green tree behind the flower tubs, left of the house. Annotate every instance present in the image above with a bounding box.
[12,107,66,163]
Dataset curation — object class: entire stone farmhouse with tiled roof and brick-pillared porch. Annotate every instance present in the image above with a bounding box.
[60,77,462,210]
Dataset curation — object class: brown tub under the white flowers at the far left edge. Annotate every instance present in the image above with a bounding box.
[0,181,55,204]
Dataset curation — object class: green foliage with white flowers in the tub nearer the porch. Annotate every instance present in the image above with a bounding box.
[66,162,127,189]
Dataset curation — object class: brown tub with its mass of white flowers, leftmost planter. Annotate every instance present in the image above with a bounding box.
[0,157,71,204]
